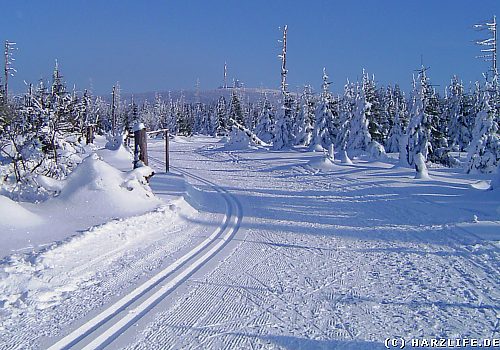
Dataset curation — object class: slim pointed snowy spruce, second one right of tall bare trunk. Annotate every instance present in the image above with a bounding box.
[310,68,337,149]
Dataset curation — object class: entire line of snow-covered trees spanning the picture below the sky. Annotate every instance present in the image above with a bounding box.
[0,63,500,197]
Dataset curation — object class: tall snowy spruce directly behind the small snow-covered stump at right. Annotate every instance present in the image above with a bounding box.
[399,69,431,167]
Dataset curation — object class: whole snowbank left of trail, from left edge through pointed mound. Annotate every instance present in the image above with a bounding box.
[0,148,158,256]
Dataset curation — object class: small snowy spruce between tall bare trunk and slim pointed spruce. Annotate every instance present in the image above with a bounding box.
[294,85,316,146]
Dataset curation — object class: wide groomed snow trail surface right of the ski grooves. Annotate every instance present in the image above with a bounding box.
[122,138,500,349]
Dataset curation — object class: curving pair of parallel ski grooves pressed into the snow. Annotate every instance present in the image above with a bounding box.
[48,157,243,350]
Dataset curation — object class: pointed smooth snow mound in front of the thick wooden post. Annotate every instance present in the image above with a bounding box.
[51,154,161,216]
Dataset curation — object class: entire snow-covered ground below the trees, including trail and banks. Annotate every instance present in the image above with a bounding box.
[0,137,500,349]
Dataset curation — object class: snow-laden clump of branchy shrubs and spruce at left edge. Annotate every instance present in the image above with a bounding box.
[0,64,82,186]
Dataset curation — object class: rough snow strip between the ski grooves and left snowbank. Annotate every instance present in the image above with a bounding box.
[0,208,207,349]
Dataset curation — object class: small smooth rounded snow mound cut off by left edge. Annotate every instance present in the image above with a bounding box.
[0,195,43,228]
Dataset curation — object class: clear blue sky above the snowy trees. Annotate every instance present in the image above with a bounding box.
[0,0,500,94]
